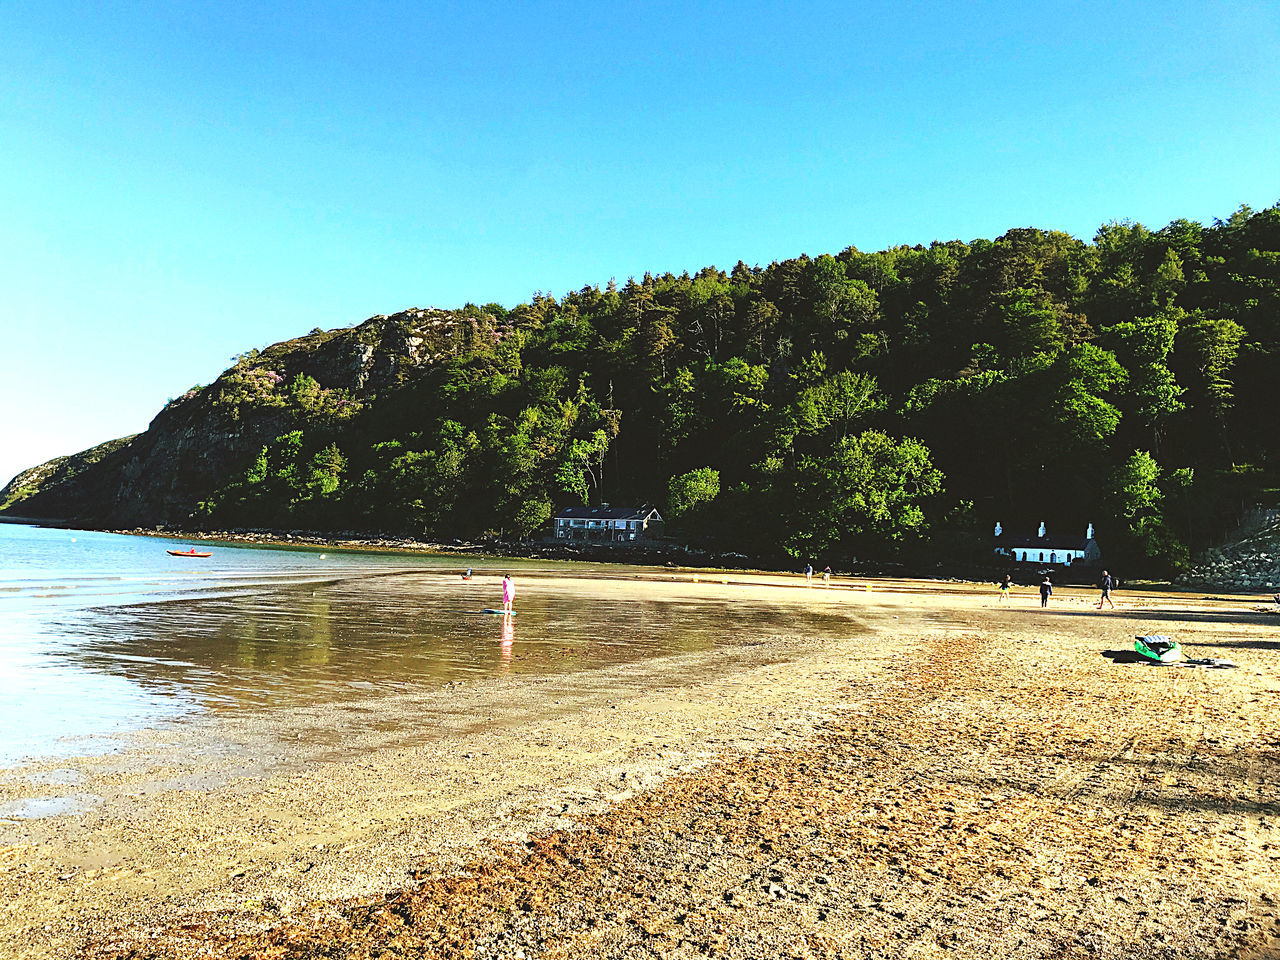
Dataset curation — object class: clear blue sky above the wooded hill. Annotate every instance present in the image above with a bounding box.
[0,0,1280,483]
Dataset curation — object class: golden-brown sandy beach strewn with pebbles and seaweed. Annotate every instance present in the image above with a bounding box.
[0,573,1280,957]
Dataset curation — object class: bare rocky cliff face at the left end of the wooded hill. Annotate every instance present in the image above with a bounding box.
[0,308,509,526]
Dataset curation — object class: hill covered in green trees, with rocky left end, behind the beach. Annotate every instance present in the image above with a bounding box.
[0,206,1280,573]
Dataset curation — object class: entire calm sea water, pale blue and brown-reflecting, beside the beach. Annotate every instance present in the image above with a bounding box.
[0,524,849,767]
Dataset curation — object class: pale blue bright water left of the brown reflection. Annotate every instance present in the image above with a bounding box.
[0,524,443,765]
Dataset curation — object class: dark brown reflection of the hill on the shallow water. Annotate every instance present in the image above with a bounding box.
[42,579,850,708]
